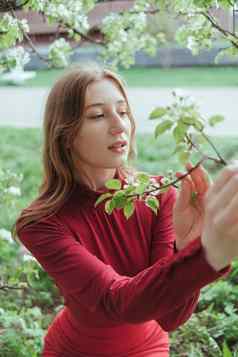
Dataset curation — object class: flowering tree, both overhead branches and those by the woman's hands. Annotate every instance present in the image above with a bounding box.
[0,0,238,217]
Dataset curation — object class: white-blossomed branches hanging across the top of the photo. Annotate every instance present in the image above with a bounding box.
[0,0,238,71]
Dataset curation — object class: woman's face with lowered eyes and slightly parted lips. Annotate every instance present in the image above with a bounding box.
[73,79,131,169]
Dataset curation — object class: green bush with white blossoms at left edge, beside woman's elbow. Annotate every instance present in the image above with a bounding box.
[0,165,62,357]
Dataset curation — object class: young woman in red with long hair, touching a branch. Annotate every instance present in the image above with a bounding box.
[16,66,238,357]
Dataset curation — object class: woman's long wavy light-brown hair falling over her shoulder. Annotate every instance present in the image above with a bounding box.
[13,64,135,238]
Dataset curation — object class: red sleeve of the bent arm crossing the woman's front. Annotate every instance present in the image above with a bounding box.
[20,200,229,327]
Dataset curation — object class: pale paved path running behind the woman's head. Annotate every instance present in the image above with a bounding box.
[0,87,238,136]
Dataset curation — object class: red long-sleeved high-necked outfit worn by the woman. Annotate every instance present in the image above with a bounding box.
[19,177,229,357]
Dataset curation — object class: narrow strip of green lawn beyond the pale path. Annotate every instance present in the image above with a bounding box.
[2,67,238,87]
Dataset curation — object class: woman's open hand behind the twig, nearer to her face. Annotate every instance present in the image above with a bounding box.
[173,163,209,250]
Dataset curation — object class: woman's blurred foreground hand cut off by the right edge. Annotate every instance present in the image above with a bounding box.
[201,162,238,270]
